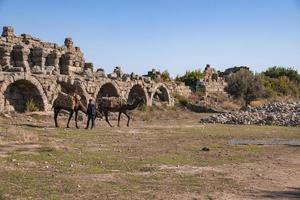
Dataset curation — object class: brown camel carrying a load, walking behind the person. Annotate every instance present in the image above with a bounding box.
[53,92,86,128]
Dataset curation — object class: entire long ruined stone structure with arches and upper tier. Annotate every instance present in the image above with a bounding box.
[0,27,189,112]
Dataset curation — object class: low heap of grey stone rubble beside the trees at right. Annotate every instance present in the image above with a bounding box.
[201,102,300,126]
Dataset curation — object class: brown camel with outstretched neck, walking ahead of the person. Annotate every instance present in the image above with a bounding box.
[98,97,144,127]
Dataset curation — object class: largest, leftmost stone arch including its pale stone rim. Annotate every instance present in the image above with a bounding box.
[0,75,50,112]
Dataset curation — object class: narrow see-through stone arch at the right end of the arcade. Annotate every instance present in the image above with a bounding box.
[151,83,172,106]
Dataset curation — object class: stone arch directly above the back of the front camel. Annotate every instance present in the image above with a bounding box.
[95,82,121,99]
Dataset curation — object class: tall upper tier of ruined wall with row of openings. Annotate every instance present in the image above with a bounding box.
[0,27,84,75]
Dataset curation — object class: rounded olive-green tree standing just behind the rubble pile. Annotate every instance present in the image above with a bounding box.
[225,69,264,106]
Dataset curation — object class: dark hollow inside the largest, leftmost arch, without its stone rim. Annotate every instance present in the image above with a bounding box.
[4,79,45,112]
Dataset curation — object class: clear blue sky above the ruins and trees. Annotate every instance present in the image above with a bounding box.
[0,0,300,76]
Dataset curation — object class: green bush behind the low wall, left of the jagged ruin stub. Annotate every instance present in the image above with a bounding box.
[175,69,205,90]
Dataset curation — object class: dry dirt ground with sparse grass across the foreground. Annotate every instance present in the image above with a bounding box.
[0,110,300,200]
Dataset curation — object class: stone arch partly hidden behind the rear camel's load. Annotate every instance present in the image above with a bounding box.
[58,79,90,105]
